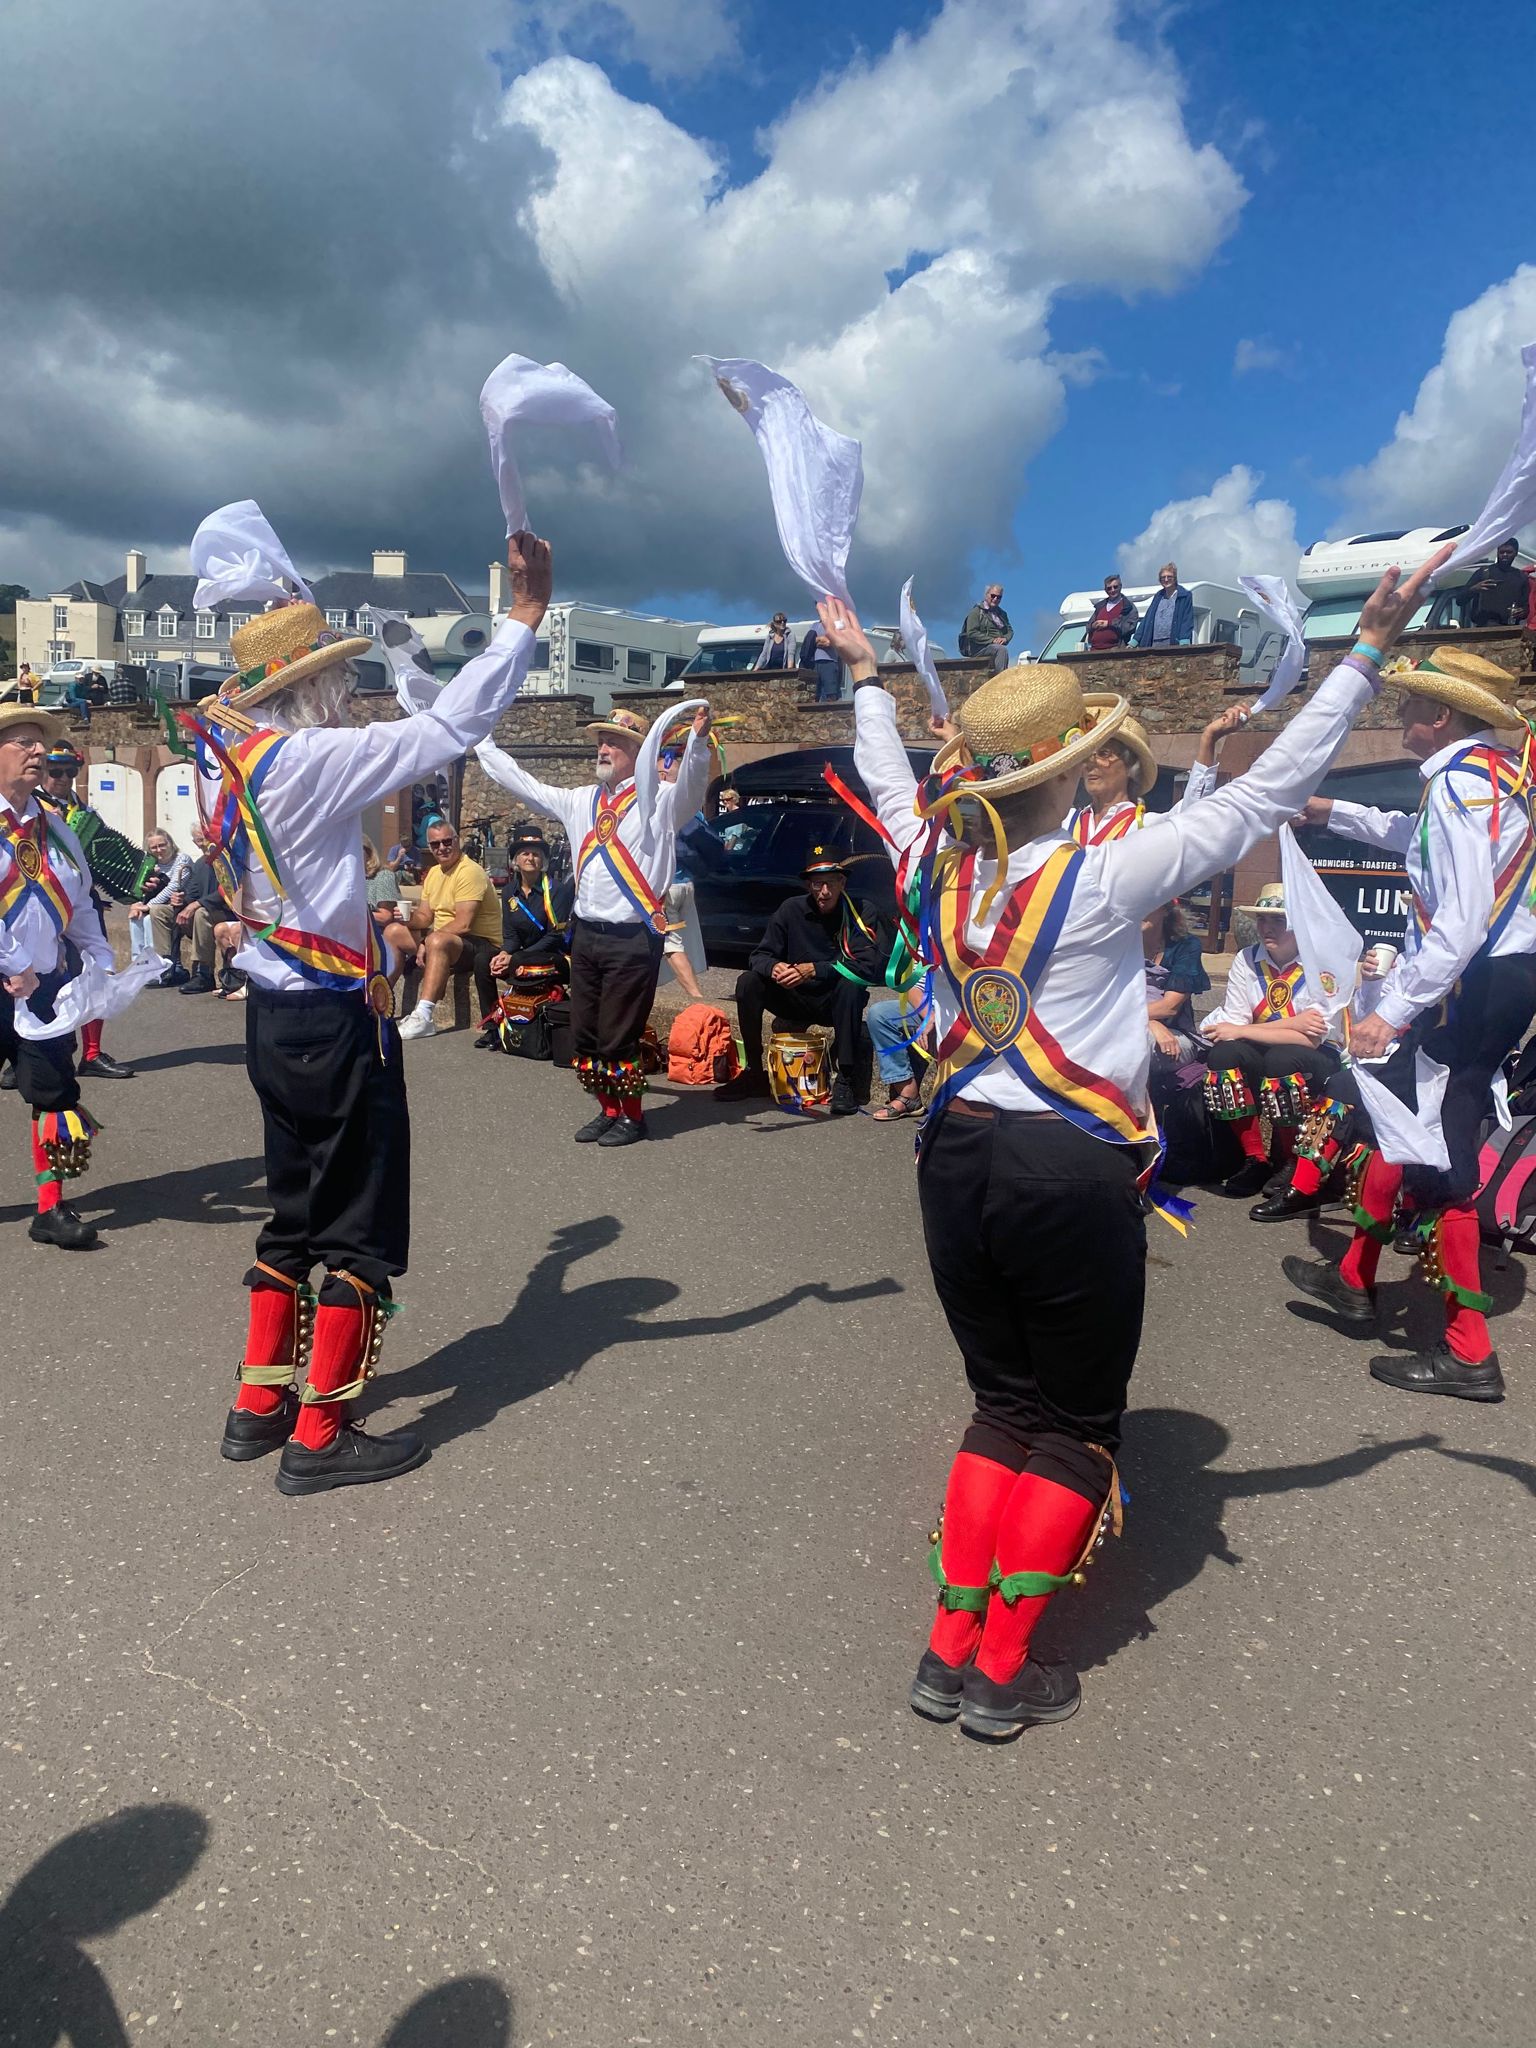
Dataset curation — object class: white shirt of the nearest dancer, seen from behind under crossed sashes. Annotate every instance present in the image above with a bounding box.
[854,662,1378,1114]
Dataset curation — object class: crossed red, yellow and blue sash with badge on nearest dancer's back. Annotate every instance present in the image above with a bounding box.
[930,846,1157,1145]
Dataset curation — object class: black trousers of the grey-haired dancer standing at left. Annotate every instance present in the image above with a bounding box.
[246,981,412,1292]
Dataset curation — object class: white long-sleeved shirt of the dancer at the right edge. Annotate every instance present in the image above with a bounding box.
[1329,731,1536,1030]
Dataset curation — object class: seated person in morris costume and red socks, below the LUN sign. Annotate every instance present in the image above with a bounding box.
[1200,883,1339,1196]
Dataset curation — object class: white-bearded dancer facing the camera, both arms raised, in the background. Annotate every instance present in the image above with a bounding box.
[475,702,713,1145]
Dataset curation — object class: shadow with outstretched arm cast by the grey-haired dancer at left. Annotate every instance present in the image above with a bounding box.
[373,1217,901,1448]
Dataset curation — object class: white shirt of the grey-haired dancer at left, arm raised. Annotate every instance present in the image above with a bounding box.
[225,618,532,989]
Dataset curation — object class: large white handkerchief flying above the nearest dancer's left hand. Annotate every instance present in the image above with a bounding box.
[698,356,864,604]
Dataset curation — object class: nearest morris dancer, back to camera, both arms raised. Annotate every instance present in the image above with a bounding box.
[821,551,1446,1739]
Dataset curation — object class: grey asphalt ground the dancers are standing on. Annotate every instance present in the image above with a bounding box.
[0,991,1536,2048]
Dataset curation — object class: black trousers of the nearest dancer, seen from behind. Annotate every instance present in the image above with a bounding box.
[918,1108,1147,1503]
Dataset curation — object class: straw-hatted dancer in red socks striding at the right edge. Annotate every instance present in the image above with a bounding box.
[1282,647,1536,1401]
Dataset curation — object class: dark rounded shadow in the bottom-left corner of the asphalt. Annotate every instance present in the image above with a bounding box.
[0,1804,208,2048]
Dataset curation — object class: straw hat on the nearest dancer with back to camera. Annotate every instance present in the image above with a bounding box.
[932,662,1151,801]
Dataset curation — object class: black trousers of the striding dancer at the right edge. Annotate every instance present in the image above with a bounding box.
[1337,952,1536,1208]
